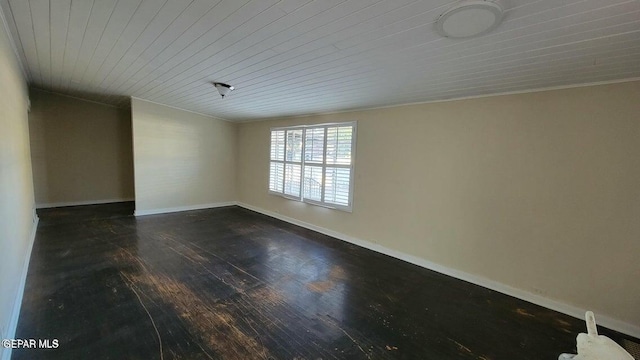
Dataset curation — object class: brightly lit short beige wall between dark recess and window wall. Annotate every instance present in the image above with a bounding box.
[132,99,236,214]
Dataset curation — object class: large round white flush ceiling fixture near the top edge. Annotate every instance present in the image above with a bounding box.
[436,0,504,39]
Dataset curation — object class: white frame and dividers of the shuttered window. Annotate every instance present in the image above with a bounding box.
[267,121,358,212]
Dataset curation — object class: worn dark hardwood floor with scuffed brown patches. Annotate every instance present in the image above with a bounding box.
[13,203,637,360]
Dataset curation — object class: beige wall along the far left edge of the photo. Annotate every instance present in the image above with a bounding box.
[0,20,34,358]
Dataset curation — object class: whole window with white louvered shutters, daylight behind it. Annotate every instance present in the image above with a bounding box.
[269,122,356,211]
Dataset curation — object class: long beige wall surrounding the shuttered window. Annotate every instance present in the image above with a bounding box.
[238,82,640,326]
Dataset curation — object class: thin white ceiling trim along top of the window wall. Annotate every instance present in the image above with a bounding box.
[238,75,640,123]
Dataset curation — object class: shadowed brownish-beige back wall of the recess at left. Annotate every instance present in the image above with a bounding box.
[29,90,133,207]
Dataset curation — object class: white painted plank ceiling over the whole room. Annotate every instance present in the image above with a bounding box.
[0,0,640,120]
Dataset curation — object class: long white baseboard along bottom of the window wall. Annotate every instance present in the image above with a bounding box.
[238,202,640,338]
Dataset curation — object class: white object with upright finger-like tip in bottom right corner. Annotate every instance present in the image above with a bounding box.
[558,311,634,360]
